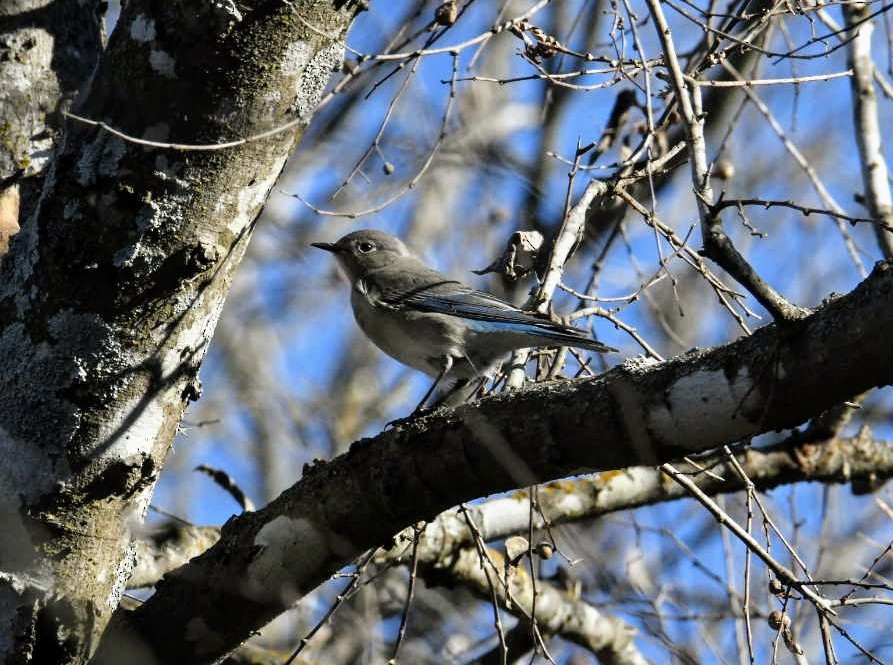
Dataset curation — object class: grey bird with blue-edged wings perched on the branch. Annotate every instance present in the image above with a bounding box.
[311,229,617,413]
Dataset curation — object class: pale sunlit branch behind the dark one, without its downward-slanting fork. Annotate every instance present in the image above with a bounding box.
[129,430,893,588]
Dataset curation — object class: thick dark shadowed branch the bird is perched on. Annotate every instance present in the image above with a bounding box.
[90,263,893,663]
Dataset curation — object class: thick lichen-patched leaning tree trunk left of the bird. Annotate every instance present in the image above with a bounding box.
[0,0,353,663]
